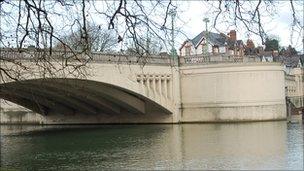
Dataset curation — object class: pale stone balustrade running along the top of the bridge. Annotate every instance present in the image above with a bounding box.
[0,48,282,66]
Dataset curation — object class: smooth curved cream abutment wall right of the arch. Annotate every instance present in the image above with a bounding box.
[181,63,286,122]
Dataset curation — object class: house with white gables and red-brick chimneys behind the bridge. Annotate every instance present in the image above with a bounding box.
[179,30,244,57]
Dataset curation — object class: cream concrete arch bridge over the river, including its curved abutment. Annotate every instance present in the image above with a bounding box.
[0,51,286,124]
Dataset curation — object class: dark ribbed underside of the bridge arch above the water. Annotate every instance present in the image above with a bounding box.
[0,78,172,115]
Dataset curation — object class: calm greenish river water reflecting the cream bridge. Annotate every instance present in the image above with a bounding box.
[0,121,303,170]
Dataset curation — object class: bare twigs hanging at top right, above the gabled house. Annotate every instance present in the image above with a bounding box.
[206,0,304,44]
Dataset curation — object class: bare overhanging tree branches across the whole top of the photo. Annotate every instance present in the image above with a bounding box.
[0,0,304,79]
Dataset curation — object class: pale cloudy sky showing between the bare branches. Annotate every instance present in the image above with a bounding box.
[1,0,304,51]
